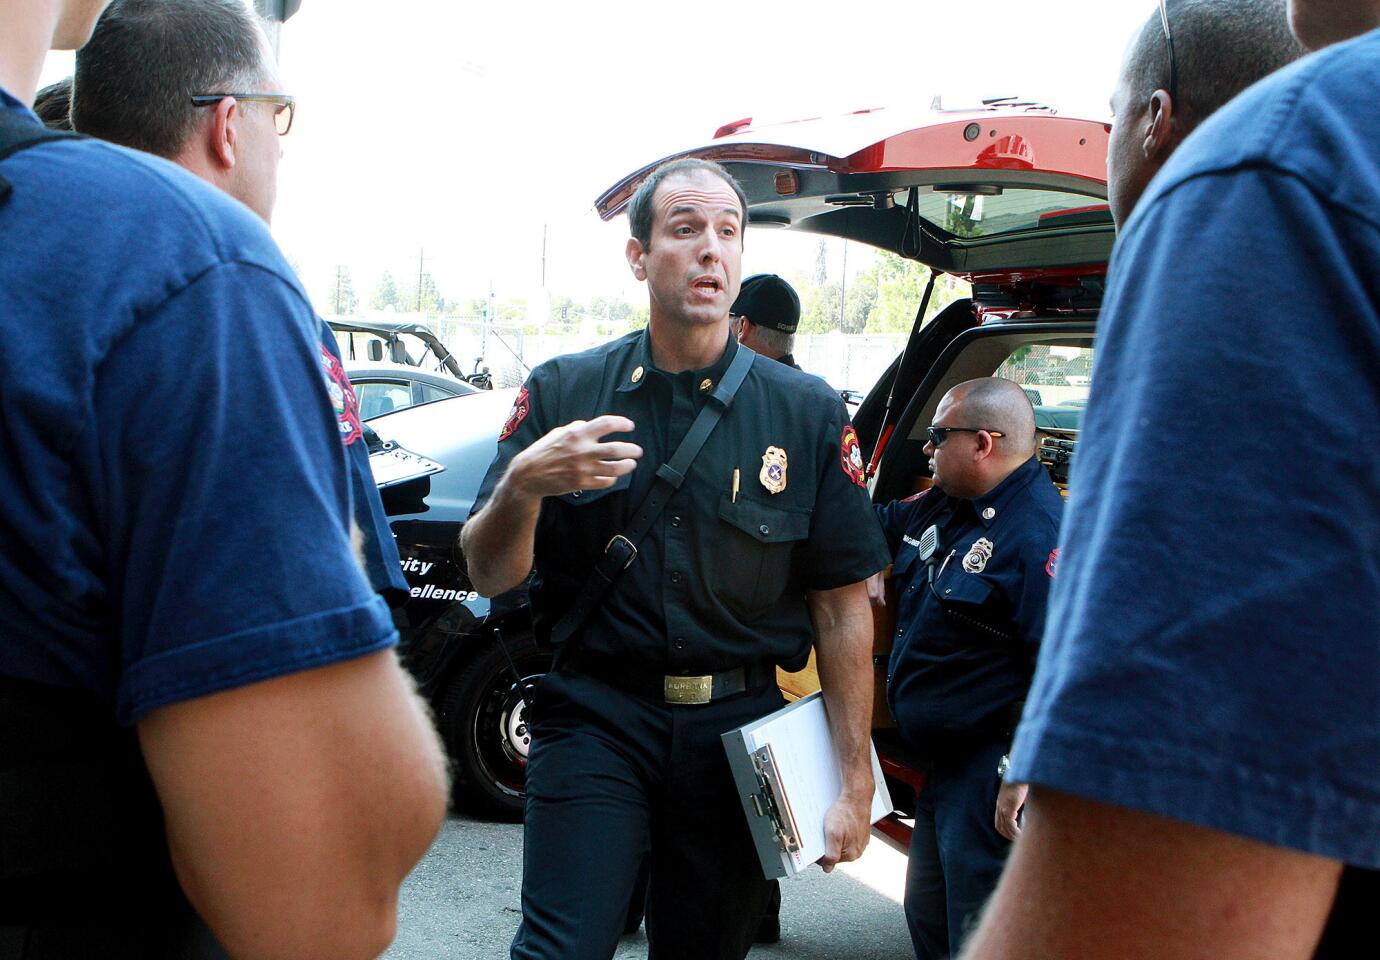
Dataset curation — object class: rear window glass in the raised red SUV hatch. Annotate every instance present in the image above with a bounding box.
[919,189,1111,240]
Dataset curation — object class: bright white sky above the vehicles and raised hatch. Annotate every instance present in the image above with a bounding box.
[44,0,1155,313]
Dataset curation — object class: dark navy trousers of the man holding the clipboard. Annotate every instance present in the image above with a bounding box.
[512,672,782,960]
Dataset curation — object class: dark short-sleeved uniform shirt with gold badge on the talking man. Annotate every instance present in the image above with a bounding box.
[475,331,886,673]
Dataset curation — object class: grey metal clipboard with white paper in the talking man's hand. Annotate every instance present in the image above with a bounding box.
[722,691,893,880]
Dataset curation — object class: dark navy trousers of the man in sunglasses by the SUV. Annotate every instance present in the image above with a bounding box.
[905,737,1012,960]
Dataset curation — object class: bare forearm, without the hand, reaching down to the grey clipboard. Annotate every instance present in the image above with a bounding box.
[810,583,874,800]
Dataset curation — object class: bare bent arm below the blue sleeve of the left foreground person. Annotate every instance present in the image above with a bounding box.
[139,651,447,960]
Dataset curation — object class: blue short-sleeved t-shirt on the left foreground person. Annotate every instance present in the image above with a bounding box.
[0,91,396,723]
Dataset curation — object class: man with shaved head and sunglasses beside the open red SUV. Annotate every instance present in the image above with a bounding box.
[874,377,1063,960]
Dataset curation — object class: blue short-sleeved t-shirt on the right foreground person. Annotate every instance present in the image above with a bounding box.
[1010,32,1380,868]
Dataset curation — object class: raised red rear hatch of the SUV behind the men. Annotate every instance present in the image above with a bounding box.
[595,103,1114,283]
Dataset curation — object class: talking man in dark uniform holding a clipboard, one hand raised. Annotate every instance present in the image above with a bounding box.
[464,160,886,960]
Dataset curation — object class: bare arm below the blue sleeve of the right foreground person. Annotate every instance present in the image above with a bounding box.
[963,786,1340,960]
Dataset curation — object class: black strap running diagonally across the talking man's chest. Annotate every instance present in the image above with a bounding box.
[551,343,756,647]
